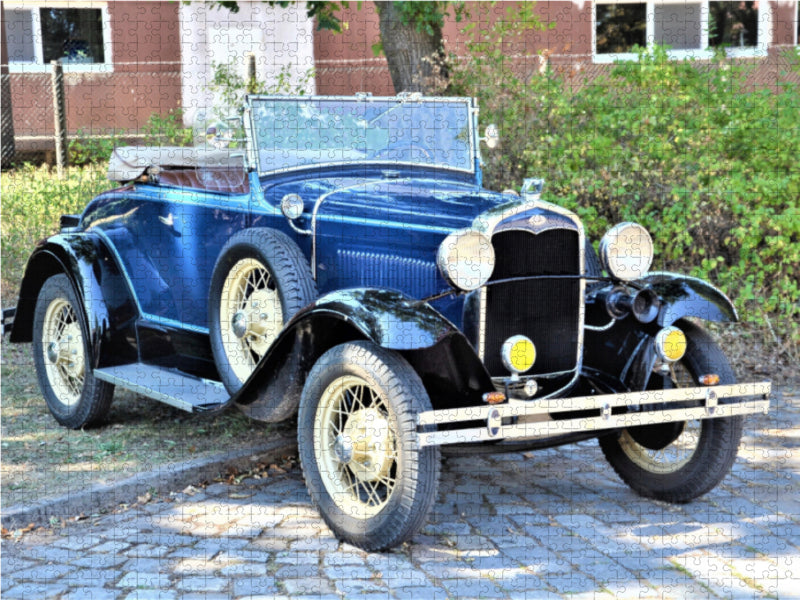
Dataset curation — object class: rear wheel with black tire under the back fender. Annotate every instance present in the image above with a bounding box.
[33,274,114,429]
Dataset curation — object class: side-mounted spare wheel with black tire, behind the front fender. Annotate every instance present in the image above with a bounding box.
[208,227,317,394]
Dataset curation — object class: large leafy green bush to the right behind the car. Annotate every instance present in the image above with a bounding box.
[452,36,800,358]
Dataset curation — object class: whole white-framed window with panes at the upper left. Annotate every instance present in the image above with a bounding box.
[4,2,111,72]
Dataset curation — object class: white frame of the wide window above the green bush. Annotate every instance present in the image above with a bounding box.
[592,0,772,63]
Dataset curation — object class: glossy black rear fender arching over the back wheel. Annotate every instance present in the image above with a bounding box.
[10,233,139,367]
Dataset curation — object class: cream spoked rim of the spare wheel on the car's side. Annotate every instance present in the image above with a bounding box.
[219,258,283,382]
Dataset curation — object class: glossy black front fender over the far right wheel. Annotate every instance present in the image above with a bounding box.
[583,272,738,392]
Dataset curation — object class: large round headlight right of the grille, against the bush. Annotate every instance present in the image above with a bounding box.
[600,223,653,281]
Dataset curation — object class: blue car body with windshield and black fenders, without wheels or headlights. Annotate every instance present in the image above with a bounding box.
[11,96,768,438]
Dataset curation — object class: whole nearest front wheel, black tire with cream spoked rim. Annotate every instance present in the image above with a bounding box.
[297,342,441,551]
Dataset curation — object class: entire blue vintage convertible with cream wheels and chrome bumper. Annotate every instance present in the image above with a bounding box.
[4,94,770,550]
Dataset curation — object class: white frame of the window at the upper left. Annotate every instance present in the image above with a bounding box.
[2,0,114,73]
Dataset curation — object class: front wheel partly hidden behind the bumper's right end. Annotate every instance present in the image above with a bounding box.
[600,321,742,503]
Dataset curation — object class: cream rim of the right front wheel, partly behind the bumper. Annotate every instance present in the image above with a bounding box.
[619,363,702,475]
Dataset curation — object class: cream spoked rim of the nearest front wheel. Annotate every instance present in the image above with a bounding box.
[314,375,398,518]
